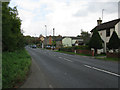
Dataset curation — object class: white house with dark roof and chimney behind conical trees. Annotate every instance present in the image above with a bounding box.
[91,18,120,53]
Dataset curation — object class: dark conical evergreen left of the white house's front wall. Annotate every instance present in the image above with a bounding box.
[89,30,102,54]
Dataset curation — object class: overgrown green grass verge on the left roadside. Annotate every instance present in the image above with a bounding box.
[2,49,31,88]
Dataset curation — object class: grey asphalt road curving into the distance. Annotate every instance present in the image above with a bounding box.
[21,47,120,88]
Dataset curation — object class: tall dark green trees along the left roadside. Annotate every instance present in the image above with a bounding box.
[2,2,24,51]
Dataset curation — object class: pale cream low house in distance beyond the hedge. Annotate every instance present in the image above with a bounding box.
[62,36,83,47]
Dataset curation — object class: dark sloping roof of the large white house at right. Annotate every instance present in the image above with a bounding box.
[90,18,120,32]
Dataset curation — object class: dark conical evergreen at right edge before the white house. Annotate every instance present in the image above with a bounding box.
[107,31,120,51]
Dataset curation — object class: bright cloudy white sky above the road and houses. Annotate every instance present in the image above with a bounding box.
[10,0,120,37]
